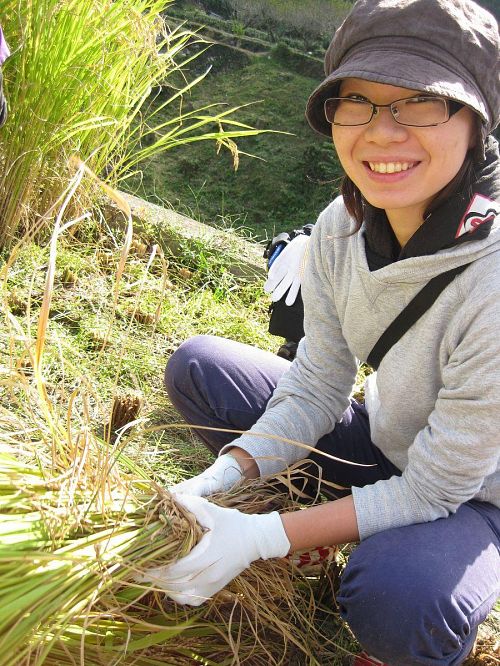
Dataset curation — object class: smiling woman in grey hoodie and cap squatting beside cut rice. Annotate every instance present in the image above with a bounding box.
[142,0,500,666]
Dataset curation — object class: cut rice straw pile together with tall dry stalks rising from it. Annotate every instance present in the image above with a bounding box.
[0,165,340,666]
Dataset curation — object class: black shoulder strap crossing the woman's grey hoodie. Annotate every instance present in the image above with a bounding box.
[367,264,470,370]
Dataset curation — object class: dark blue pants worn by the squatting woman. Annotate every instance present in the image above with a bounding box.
[165,336,500,666]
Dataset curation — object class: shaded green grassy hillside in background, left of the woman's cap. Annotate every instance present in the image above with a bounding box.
[128,0,500,239]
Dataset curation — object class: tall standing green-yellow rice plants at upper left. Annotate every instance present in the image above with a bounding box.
[0,0,266,247]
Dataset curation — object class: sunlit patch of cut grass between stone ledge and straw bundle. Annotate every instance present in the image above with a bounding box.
[1,220,273,395]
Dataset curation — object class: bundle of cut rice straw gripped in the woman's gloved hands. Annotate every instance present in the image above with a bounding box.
[0,438,336,666]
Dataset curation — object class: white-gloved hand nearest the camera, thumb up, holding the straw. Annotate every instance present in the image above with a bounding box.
[140,495,290,606]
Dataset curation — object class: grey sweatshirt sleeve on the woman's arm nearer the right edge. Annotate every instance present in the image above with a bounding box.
[353,285,500,539]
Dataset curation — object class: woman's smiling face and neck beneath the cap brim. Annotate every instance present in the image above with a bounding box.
[327,78,481,247]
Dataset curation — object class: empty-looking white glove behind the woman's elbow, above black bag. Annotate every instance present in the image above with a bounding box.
[264,234,309,305]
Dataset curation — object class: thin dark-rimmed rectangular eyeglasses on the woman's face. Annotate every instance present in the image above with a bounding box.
[324,95,462,127]
